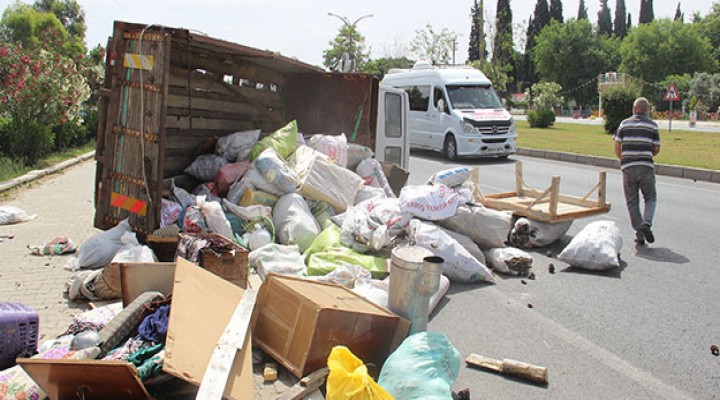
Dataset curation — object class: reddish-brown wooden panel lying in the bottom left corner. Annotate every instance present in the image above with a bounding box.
[18,358,151,400]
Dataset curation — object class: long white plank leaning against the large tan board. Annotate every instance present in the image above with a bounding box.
[196,289,257,400]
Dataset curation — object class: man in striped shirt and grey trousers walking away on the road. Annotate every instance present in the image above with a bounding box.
[615,97,660,245]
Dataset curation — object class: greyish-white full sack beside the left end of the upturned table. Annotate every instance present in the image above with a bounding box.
[438,204,512,250]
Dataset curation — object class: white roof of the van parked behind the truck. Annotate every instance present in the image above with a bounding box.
[382,63,492,86]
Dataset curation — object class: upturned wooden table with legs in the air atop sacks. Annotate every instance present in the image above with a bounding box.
[475,161,610,223]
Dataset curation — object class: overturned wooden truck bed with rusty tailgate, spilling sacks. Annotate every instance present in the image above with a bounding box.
[95,21,379,234]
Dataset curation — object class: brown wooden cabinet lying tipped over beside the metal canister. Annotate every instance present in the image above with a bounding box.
[251,274,410,377]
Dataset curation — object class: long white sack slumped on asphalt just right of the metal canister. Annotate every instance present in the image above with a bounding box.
[408,219,495,283]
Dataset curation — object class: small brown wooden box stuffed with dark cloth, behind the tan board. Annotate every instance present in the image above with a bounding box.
[180,233,249,289]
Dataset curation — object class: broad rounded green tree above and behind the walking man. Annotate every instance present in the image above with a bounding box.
[620,18,718,82]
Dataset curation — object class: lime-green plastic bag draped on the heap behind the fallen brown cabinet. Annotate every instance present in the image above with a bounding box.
[307,246,387,279]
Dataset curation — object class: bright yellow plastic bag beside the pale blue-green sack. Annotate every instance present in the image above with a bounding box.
[326,346,393,400]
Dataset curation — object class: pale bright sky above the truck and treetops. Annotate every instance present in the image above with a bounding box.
[0,0,717,66]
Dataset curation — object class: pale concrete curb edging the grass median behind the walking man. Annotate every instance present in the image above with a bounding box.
[517,147,720,183]
